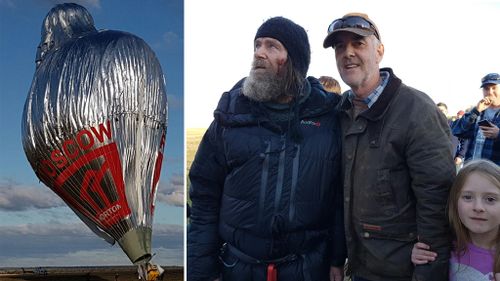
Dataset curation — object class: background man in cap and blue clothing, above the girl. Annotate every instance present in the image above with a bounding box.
[453,73,500,165]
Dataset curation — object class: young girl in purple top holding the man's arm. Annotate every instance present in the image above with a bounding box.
[411,159,500,281]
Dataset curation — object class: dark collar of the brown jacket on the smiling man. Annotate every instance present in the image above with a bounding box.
[340,68,402,121]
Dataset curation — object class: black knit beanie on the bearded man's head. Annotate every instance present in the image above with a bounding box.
[254,17,311,77]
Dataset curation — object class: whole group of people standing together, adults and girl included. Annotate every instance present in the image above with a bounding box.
[187,10,500,281]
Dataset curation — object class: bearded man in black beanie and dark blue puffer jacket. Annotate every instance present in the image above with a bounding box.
[187,17,346,281]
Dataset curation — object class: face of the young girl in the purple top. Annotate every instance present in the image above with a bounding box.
[457,173,500,245]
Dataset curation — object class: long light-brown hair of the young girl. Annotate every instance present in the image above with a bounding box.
[448,159,500,273]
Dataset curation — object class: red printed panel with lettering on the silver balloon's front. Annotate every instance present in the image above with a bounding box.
[38,121,131,229]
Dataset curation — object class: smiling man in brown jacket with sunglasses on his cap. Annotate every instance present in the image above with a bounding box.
[323,13,455,281]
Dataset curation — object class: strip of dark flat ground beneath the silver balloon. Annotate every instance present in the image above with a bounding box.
[0,267,184,281]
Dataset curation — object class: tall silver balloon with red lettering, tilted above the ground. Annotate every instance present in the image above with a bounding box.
[22,4,167,276]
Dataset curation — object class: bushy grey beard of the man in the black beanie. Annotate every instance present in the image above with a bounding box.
[243,68,286,102]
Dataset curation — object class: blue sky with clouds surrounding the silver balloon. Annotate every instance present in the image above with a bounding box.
[0,0,184,267]
